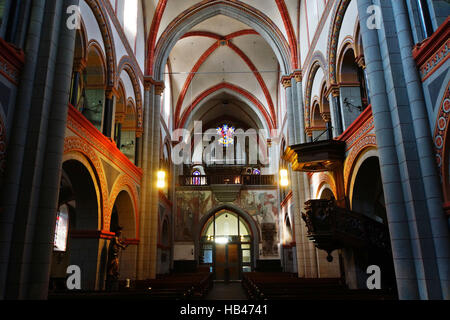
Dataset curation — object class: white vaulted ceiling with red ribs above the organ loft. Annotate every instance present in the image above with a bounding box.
[144,0,299,128]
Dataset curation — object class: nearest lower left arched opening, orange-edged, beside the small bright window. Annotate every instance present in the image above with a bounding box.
[55,156,104,290]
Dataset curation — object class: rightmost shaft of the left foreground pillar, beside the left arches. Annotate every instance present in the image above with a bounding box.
[27,0,79,299]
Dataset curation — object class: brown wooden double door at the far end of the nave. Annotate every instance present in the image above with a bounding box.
[215,243,240,280]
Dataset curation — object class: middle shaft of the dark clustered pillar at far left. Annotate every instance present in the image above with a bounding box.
[2,1,70,299]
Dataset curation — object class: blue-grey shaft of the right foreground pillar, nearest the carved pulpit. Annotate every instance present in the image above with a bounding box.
[358,0,419,299]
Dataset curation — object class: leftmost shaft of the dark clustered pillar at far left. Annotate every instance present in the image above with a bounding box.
[0,0,46,299]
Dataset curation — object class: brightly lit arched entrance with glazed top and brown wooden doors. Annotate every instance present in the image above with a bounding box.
[200,210,253,281]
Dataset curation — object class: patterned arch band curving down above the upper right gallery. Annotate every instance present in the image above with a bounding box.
[328,0,351,85]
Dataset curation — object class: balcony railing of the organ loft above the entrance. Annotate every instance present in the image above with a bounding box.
[179,174,275,186]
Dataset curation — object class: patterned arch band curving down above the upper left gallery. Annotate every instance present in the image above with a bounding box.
[85,0,116,89]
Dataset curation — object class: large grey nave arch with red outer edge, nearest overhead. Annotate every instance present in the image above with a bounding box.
[151,0,293,81]
